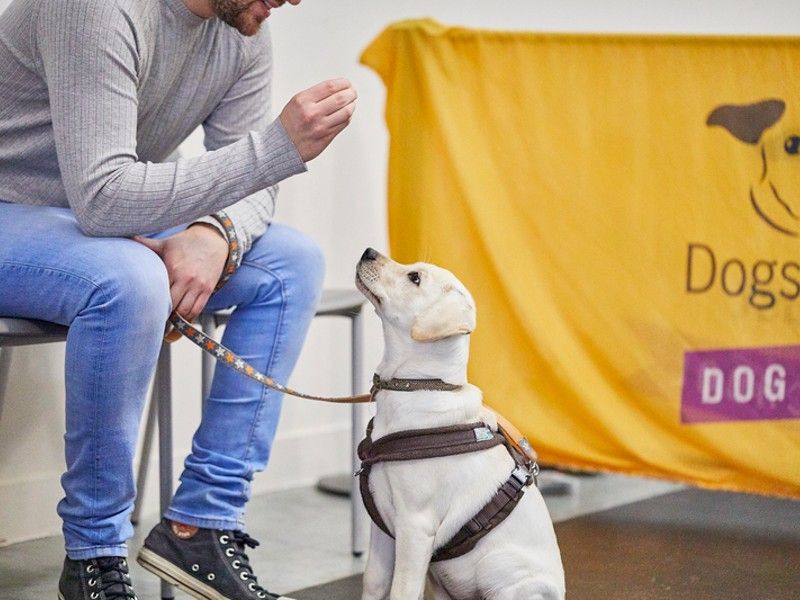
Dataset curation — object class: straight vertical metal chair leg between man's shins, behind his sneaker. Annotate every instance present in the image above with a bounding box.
[155,343,175,600]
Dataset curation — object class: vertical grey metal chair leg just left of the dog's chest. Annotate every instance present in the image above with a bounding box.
[350,311,369,556]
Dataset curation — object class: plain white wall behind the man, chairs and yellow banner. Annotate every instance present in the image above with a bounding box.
[0,0,800,544]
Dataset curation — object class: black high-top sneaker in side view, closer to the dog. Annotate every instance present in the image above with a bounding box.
[136,519,291,600]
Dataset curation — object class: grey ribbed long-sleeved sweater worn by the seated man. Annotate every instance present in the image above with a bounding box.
[0,0,305,250]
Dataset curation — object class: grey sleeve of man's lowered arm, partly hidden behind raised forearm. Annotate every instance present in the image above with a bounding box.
[192,23,278,252]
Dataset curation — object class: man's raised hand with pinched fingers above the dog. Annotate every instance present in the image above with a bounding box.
[280,79,357,162]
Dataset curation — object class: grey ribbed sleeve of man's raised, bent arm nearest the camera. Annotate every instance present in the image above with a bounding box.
[36,0,305,236]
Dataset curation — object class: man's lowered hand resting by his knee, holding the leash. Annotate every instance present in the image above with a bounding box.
[133,223,228,322]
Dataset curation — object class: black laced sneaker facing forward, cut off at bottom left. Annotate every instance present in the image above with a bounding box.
[58,556,137,600]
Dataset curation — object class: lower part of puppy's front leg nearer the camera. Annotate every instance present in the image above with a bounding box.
[389,523,433,600]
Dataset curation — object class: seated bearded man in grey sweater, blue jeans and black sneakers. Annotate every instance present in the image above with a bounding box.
[0,0,356,600]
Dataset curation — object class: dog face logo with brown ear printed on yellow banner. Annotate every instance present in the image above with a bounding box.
[706,98,800,237]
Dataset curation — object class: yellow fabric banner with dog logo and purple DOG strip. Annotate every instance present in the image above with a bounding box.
[362,20,800,498]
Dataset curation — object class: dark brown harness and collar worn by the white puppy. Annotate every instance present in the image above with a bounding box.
[355,375,539,562]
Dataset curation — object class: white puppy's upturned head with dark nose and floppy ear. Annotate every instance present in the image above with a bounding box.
[356,248,475,342]
